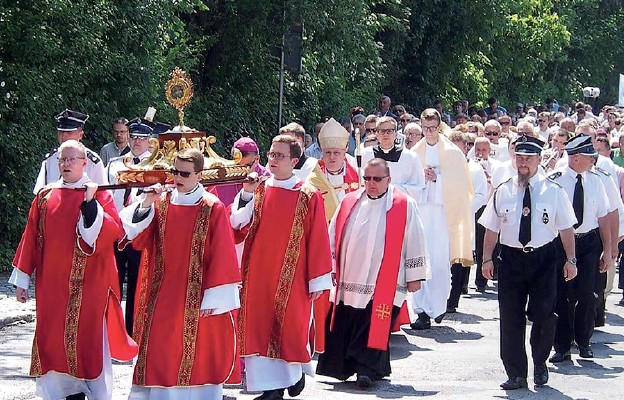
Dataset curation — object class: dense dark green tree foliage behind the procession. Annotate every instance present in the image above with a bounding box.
[0,0,624,268]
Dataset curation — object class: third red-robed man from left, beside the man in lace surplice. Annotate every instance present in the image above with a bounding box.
[230,135,332,400]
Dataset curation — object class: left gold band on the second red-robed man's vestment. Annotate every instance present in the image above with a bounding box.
[134,192,171,385]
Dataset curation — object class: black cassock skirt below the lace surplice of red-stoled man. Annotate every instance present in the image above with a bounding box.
[316,301,400,381]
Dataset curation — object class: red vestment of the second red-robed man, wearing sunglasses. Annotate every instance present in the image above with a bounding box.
[132,193,240,387]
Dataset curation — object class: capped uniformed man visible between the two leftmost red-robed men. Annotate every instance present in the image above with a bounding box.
[108,118,154,335]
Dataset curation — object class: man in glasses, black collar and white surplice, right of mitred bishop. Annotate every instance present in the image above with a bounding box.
[362,117,425,199]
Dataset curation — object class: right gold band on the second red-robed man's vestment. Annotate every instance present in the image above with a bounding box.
[176,201,212,386]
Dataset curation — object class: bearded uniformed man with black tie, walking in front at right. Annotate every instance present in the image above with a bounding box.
[479,136,576,390]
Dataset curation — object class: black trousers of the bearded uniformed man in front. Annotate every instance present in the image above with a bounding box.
[498,240,562,378]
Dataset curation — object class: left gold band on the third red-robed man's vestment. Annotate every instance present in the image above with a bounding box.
[236,181,266,355]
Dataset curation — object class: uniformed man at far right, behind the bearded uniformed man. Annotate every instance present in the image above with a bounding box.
[550,135,612,363]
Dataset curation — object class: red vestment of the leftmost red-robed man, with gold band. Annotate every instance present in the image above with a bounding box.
[13,187,137,379]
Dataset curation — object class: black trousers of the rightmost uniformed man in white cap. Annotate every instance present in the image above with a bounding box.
[554,229,602,353]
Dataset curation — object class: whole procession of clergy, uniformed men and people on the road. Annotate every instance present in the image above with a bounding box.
[10,96,624,400]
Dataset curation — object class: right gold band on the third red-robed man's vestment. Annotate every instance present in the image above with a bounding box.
[267,183,316,358]
